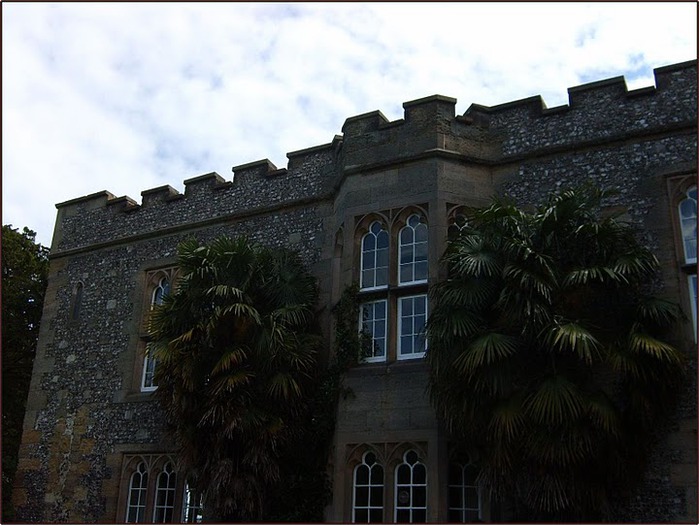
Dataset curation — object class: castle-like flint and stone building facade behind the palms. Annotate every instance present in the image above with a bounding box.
[14,61,697,522]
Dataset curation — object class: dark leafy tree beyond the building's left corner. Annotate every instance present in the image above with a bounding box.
[2,225,49,521]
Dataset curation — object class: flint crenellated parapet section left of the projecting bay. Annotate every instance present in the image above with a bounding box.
[52,137,339,255]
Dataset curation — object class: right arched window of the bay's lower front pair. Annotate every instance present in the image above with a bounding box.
[395,450,427,523]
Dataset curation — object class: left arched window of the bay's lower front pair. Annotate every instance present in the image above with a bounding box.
[352,452,383,523]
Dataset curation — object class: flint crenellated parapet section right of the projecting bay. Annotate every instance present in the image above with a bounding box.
[464,60,697,159]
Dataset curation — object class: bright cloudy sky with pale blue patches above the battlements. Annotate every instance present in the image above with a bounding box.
[2,1,697,246]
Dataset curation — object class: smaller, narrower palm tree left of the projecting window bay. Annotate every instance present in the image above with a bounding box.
[150,237,320,521]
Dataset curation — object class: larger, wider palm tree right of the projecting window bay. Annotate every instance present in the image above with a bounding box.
[427,186,683,520]
